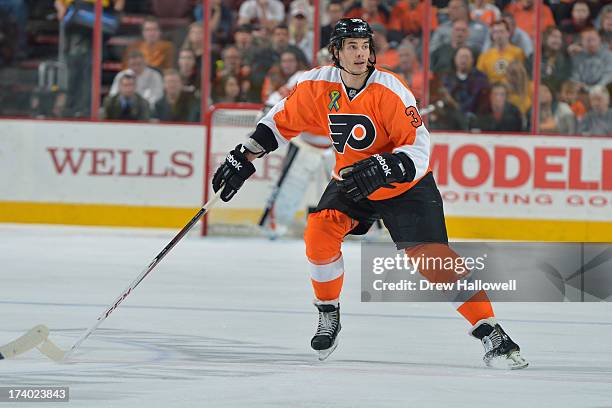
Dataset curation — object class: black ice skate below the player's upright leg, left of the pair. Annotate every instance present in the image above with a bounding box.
[310,300,341,361]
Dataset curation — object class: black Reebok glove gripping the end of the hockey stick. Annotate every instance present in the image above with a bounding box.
[213,145,255,202]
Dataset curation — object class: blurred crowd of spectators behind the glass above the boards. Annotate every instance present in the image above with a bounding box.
[0,0,612,136]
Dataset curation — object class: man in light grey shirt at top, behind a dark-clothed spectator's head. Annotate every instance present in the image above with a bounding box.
[429,0,489,52]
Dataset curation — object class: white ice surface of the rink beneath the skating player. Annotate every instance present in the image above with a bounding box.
[0,225,612,408]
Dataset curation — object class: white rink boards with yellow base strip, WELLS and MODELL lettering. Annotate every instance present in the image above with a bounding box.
[0,120,612,241]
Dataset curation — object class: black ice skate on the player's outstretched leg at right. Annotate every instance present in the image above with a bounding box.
[470,317,529,370]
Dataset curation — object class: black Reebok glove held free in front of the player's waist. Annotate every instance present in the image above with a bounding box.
[337,153,416,201]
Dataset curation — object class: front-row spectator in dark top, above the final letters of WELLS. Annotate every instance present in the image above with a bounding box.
[153,69,199,122]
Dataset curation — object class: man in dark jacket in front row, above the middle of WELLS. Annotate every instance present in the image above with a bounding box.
[102,74,150,120]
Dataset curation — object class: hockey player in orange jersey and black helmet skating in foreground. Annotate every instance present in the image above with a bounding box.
[212,18,527,368]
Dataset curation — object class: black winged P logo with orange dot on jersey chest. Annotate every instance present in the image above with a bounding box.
[327,114,376,154]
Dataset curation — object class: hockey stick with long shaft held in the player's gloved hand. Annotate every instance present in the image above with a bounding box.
[35,189,223,361]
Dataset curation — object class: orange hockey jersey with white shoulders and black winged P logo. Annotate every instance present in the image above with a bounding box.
[259,66,431,200]
